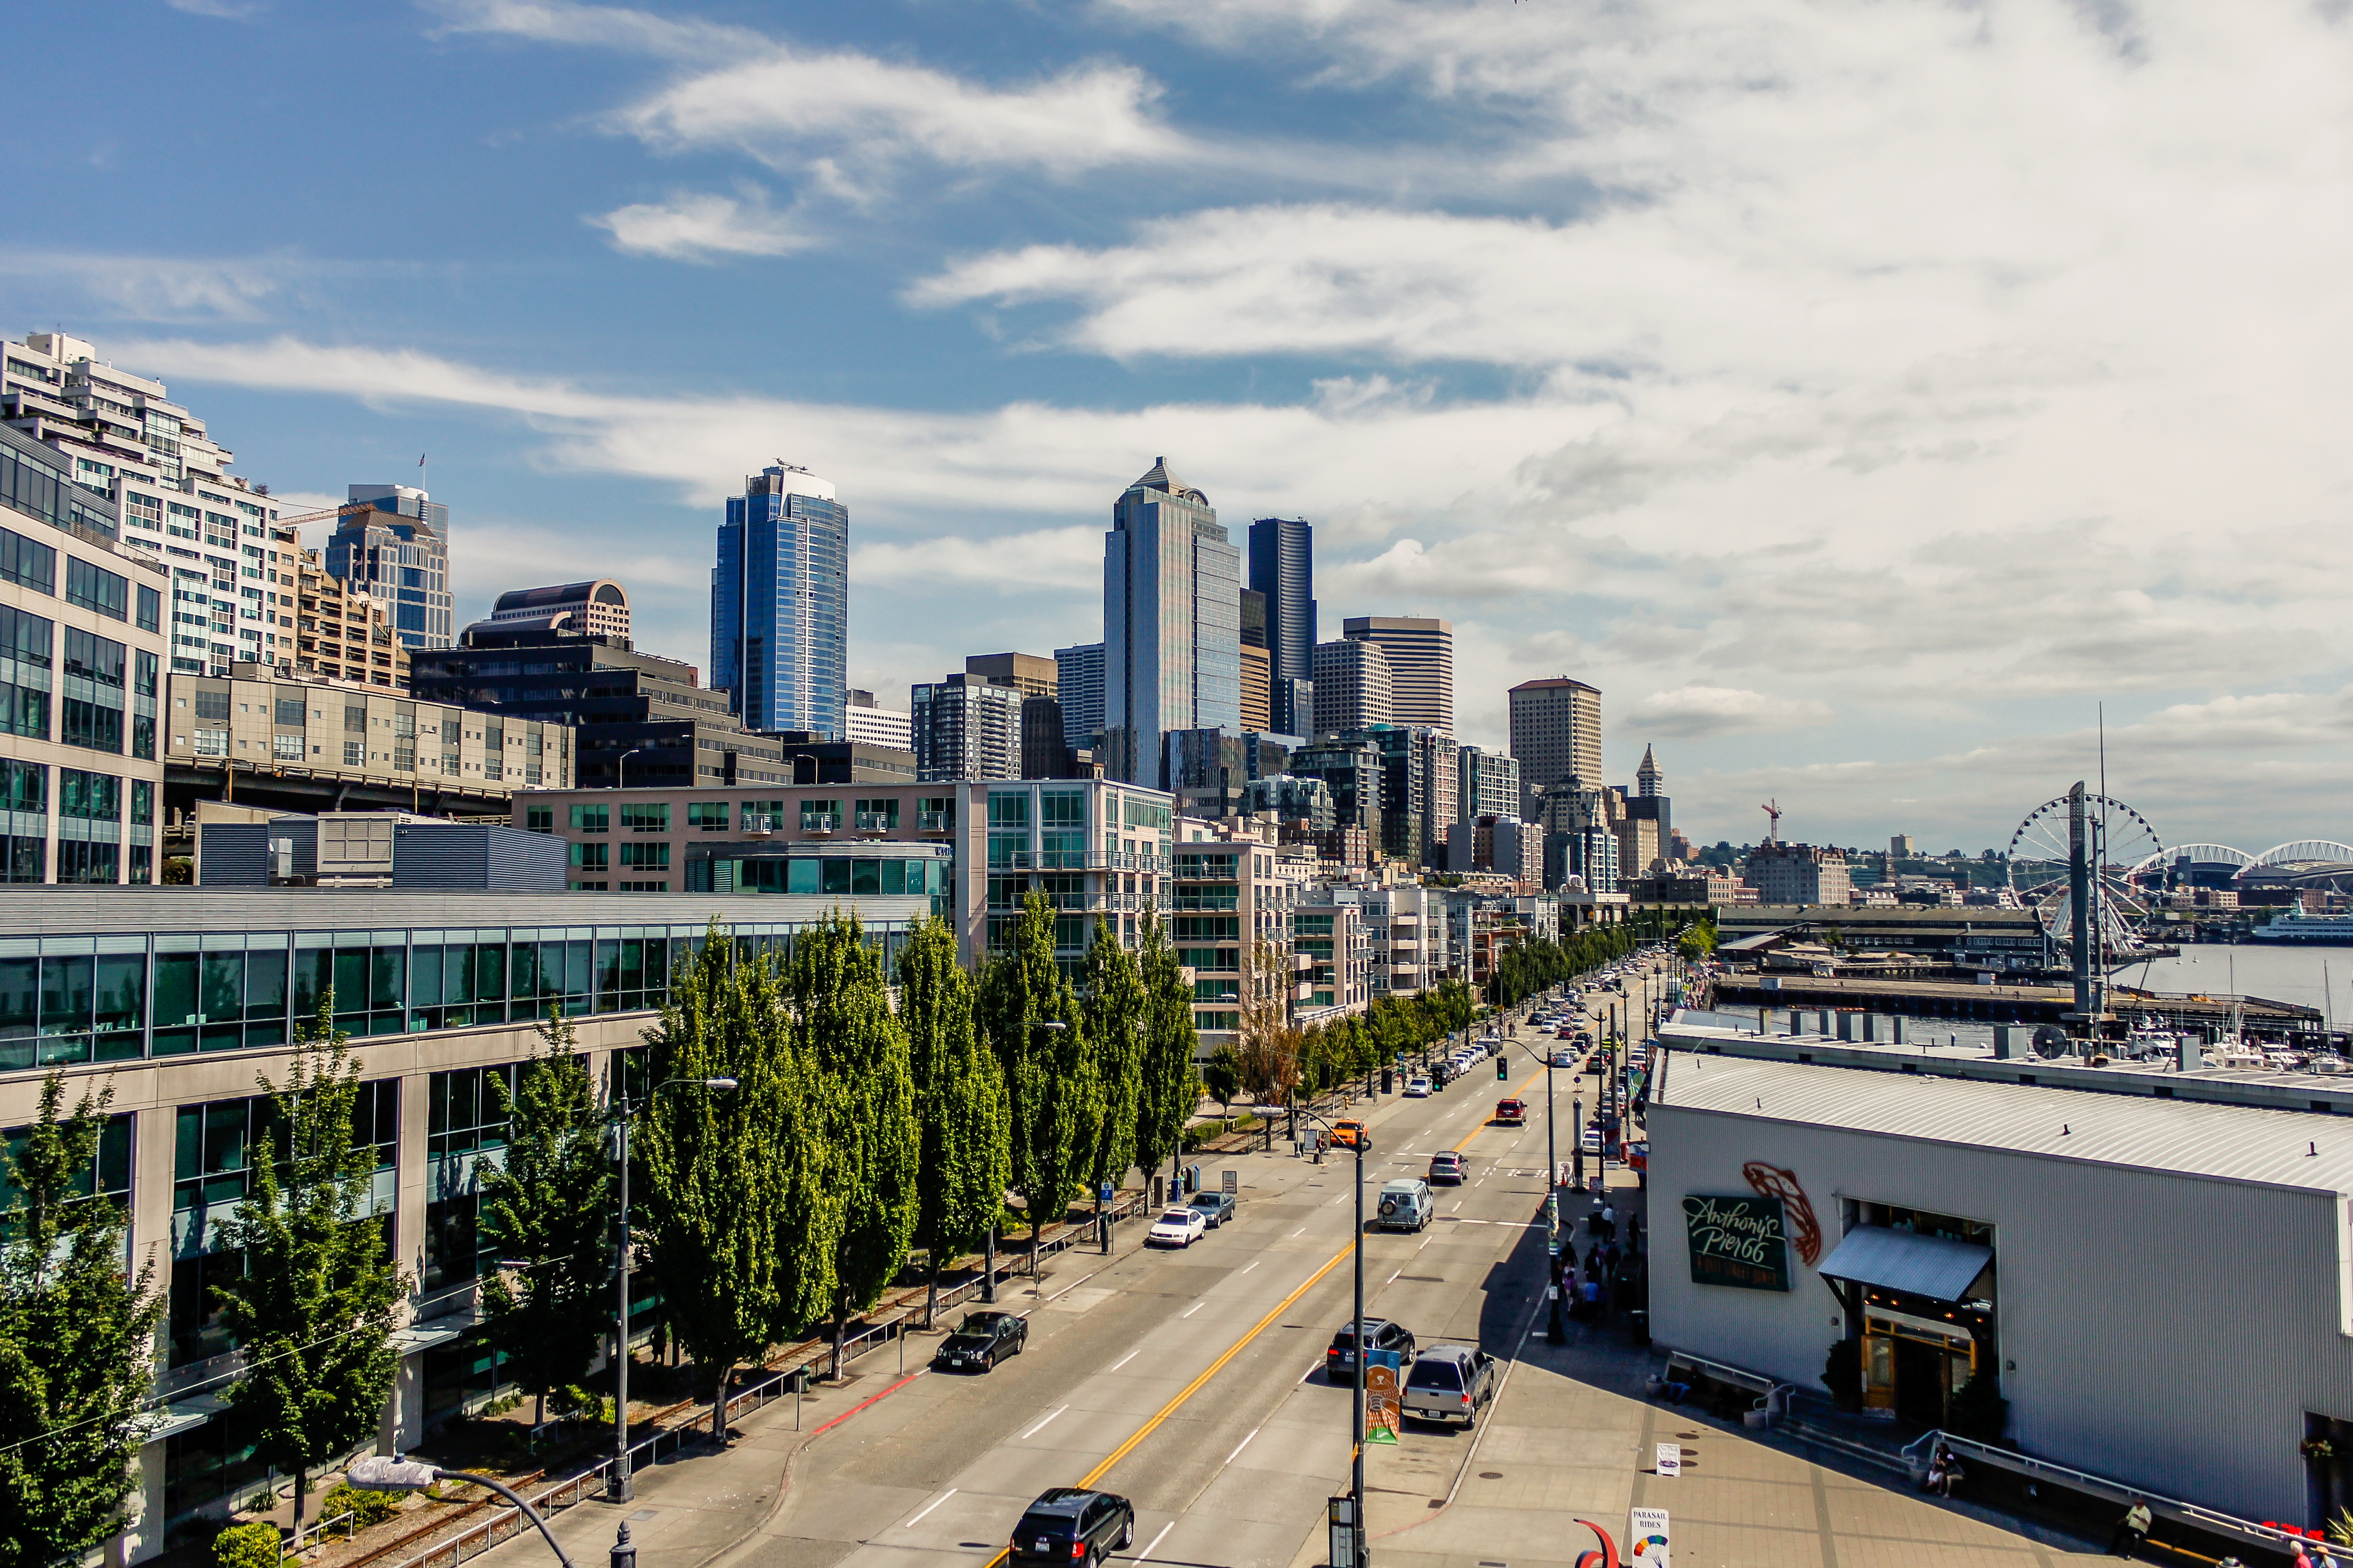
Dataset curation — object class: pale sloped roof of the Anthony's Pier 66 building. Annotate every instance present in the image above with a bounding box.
[1652,1051,2353,1201]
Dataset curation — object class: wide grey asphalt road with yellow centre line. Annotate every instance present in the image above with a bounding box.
[727,968,1635,1568]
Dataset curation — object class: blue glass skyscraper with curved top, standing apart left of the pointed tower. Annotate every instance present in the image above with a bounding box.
[710,463,849,741]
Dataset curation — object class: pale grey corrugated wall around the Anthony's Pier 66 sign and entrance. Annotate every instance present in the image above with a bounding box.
[1649,1105,2353,1521]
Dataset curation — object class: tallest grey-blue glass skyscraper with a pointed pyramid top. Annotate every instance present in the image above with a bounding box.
[1104,458,1242,785]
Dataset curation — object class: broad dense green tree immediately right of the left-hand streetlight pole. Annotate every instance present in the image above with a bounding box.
[633,924,840,1446]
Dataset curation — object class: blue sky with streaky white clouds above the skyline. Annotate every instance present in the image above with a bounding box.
[0,0,2353,849]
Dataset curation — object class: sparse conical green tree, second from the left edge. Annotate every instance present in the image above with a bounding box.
[219,992,407,1533]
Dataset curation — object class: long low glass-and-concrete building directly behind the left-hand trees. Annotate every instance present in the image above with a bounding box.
[0,883,929,1563]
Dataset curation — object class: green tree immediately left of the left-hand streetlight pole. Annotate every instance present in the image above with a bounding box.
[480,1015,617,1422]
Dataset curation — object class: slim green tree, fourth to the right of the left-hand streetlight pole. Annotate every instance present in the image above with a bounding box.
[981,893,1101,1241]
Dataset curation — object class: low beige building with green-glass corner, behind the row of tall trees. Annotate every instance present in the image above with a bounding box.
[513,778,1176,966]
